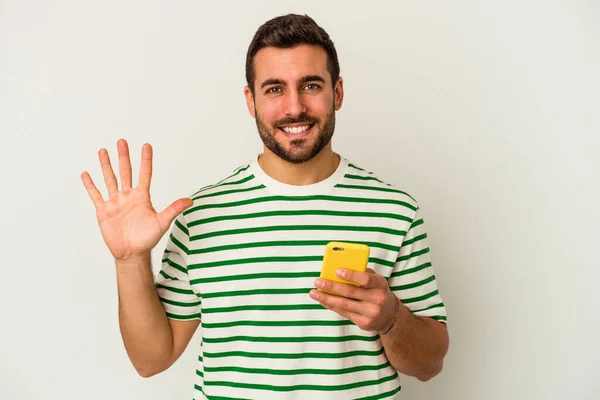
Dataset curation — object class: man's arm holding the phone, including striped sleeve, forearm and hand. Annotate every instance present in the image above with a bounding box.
[310,205,449,381]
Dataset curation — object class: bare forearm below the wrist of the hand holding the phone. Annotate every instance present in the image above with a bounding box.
[381,304,449,381]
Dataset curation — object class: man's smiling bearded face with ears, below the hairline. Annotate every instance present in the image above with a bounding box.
[245,45,343,163]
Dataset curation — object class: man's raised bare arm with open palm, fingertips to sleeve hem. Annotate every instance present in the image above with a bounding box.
[81,139,199,376]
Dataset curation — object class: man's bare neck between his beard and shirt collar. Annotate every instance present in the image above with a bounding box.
[258,143,341,186]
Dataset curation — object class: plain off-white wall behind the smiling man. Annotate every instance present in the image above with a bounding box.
[0,0,600,400]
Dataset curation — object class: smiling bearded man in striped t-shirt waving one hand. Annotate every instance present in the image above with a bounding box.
[82,15,448,399]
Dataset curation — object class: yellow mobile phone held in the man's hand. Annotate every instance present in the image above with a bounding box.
[318,242,370,294]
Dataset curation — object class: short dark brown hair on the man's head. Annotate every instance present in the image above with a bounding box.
[246,14,340,93]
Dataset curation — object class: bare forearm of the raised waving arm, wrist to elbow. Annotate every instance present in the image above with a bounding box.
[116,254,173,376]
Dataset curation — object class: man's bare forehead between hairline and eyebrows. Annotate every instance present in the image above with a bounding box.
[254,45,331,85]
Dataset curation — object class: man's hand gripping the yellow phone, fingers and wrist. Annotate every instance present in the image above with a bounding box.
[309,268,398,331]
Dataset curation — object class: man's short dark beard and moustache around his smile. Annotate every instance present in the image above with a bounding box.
[256,107,335,164]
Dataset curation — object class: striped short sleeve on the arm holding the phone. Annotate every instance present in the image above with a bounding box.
[388,208,447,323]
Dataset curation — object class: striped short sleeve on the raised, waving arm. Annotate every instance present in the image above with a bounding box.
[155,214,201,320]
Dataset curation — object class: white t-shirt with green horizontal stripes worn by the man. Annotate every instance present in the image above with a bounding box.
[156,157,446,400]
